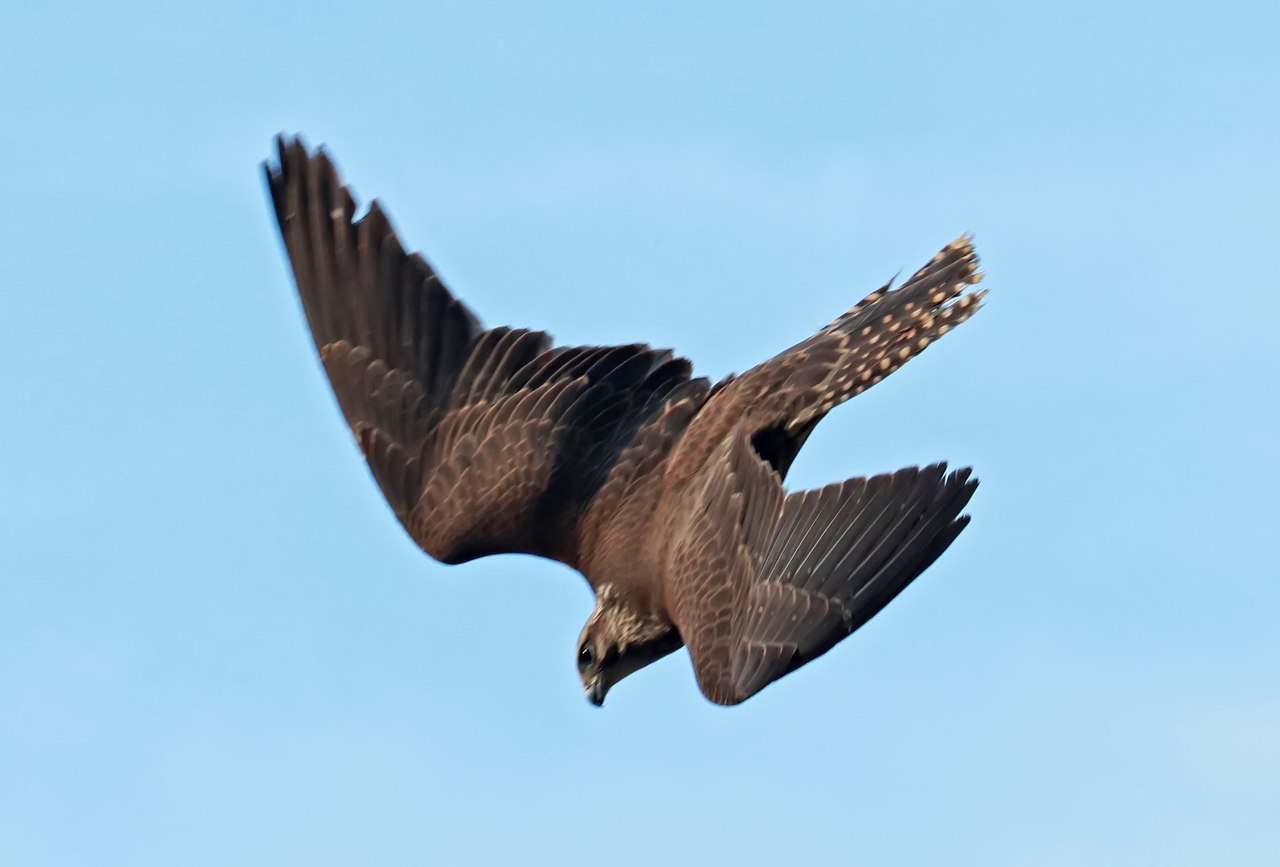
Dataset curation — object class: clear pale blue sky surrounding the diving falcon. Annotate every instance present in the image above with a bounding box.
[0,0,1280,867]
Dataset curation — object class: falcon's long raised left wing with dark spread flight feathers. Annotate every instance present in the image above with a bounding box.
[266,137,690,566]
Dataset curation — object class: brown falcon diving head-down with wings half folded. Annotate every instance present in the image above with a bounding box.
[262,134,986,706]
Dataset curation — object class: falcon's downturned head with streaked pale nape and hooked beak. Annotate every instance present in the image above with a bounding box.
[577,588,684,707]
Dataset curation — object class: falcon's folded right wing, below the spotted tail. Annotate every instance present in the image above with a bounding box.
[667,430,977,704]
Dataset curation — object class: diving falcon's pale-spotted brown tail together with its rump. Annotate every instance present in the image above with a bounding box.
[667,236,986,483]
